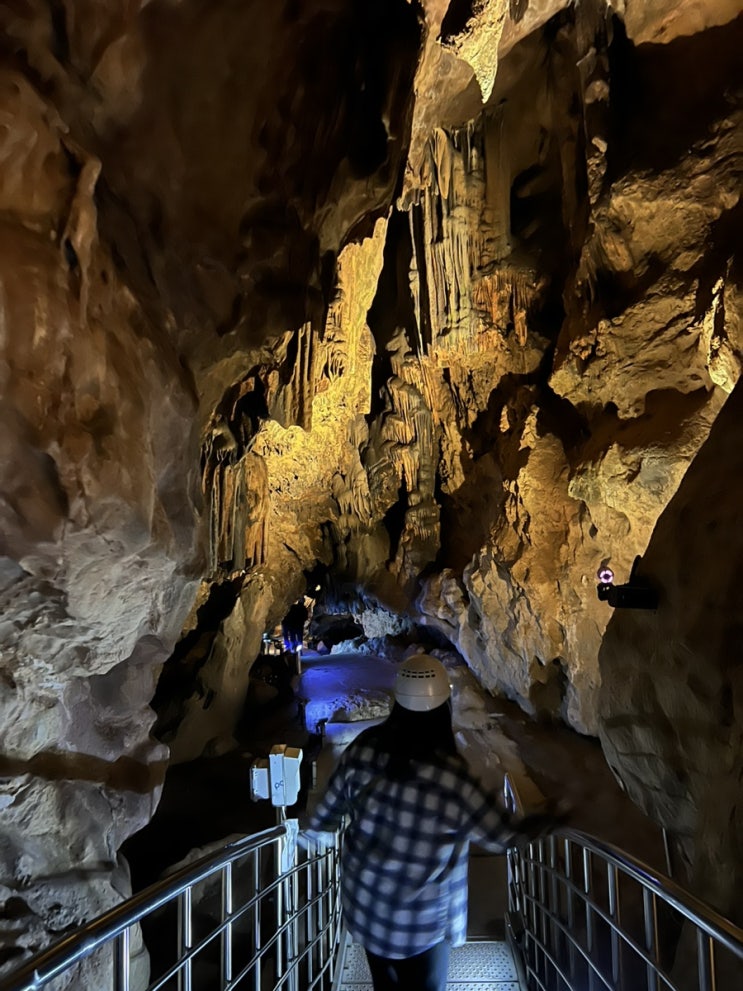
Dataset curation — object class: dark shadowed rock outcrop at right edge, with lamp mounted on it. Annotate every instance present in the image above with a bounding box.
[600,376,743,925]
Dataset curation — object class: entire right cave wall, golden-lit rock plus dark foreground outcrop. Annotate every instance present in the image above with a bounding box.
[390,3,743,921]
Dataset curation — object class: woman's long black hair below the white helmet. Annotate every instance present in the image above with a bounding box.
[362,700,459,781]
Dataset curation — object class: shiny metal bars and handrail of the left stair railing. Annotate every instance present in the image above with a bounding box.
[0,820,340,991]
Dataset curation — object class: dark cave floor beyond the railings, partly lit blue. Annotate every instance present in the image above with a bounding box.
[122,652,665,891]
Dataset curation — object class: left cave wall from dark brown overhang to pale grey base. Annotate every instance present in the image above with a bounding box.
[0,0,420,967]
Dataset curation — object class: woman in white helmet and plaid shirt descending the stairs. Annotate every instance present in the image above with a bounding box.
[309,654,555,991]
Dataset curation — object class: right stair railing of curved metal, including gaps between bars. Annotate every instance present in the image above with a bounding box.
[504,775,743,991]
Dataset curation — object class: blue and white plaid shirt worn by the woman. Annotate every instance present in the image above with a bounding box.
[309,735,514,959]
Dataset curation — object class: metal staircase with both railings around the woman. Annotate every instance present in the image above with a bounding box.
[0,782,743,991]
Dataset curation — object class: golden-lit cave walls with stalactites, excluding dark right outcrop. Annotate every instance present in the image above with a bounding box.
[0,0,743,965]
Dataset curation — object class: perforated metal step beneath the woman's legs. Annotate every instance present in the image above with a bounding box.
[338,942,519,991]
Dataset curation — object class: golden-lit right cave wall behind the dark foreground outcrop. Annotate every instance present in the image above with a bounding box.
[390,4,741,733]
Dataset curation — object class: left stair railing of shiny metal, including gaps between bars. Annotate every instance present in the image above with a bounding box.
[0,820,341,991]
